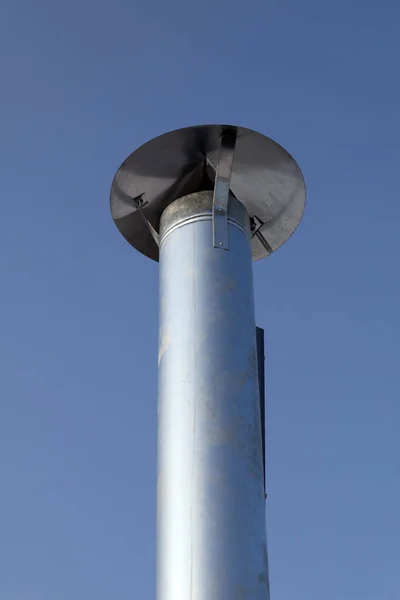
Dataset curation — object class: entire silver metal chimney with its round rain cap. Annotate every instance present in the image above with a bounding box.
[110,125,305,600]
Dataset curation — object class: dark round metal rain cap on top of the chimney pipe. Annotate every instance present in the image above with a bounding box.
[110,125,306,260]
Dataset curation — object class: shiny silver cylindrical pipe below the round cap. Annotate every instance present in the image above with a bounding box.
[157,192,269,600]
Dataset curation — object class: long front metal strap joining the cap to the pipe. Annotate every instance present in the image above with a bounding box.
[213,128,237,250]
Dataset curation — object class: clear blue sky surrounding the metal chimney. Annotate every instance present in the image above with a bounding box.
[0,0,400,600]
